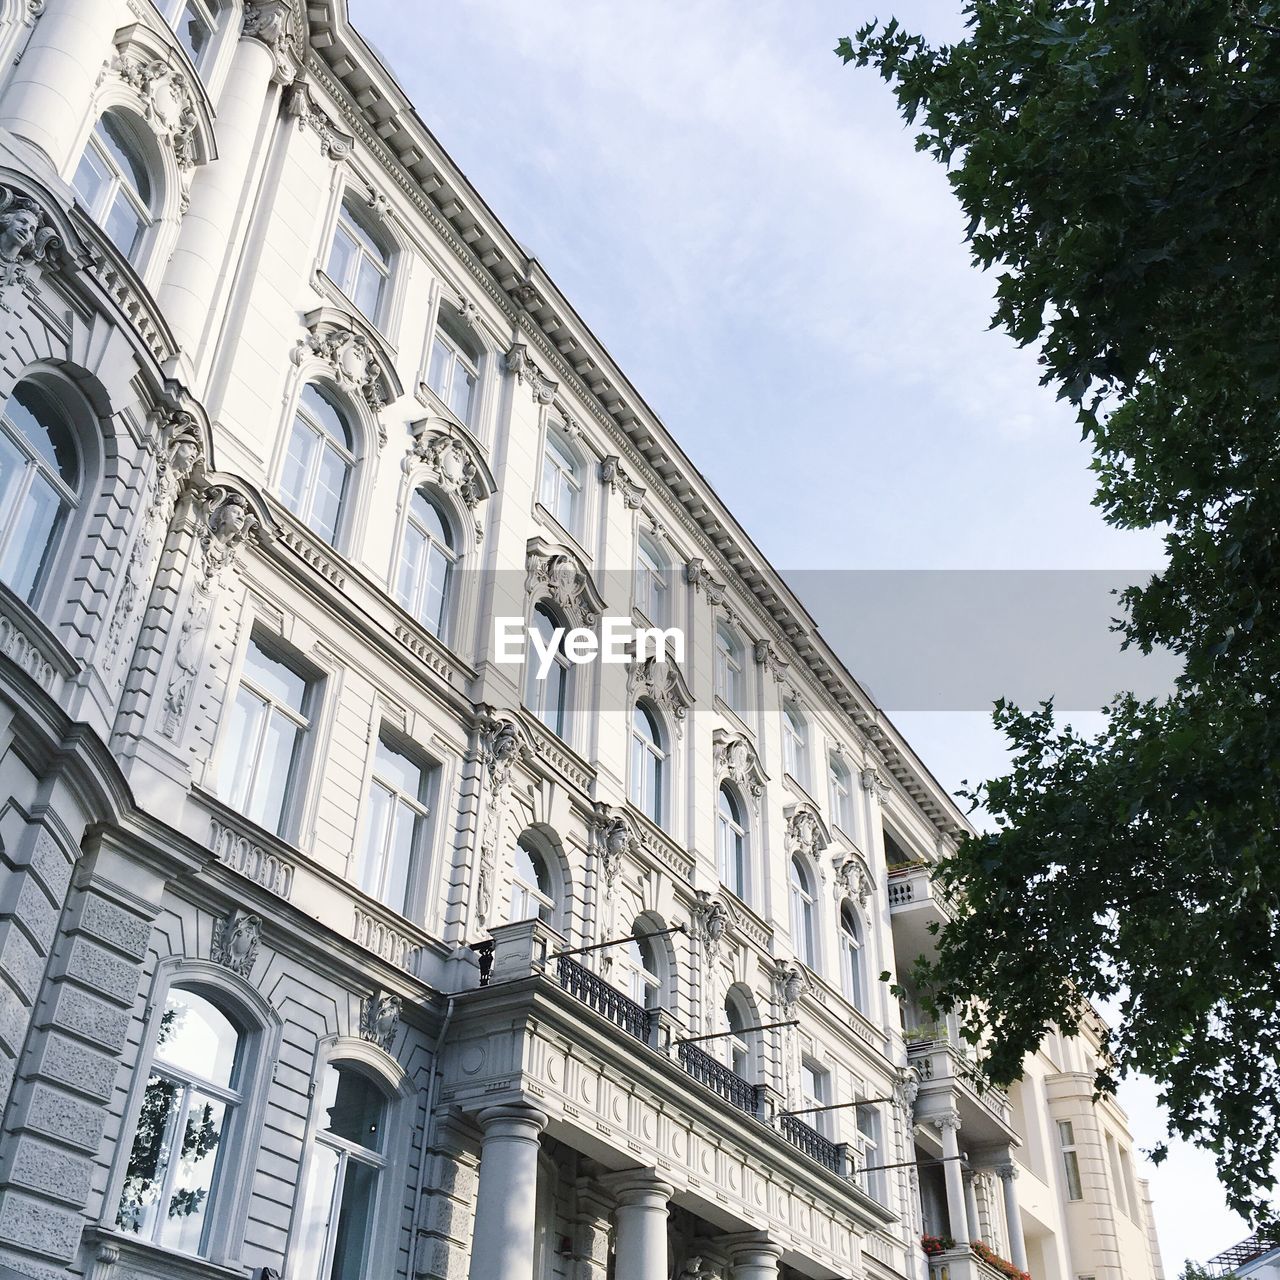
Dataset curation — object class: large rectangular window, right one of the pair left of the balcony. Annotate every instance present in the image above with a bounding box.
[355,736,431,914]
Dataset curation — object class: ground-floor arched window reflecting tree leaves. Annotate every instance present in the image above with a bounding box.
[115,987,243,1254]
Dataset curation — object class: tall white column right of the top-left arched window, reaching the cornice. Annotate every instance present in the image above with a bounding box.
[159,0,289,369]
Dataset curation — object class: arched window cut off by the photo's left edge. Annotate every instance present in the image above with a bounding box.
[0,381,81,604]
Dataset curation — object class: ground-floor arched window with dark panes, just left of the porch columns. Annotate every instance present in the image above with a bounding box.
[288,1062,390,1280]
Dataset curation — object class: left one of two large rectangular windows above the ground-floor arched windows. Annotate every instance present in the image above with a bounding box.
[220,637,316,836]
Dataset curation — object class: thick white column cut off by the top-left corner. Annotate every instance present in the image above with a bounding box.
[0,0,122,173]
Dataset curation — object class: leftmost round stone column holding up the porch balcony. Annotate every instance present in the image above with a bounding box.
[470,1102,550,1280]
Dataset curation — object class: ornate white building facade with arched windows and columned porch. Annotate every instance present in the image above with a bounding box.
[0,0,1160,1280]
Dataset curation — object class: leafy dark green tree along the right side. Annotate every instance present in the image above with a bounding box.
[836,0,1280,1219]
